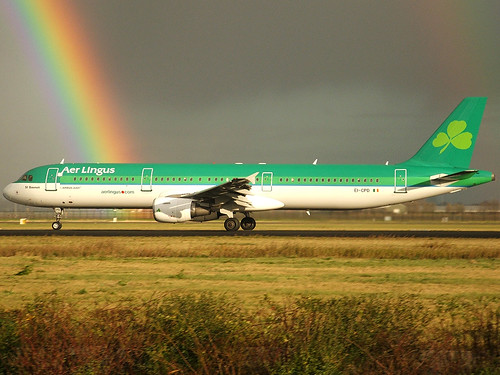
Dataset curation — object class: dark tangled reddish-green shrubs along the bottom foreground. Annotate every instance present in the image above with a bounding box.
[0,293,500,374]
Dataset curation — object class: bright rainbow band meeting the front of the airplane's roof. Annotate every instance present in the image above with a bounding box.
[4,0,135,162]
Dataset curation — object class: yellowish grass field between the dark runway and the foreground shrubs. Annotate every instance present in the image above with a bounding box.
[0,231,500,308]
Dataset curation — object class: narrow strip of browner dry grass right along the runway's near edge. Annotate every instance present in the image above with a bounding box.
[0,236,500,259]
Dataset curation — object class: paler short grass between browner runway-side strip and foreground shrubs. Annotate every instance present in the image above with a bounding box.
[0,251,500,308]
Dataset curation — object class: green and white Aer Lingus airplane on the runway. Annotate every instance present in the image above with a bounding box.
[3,97,495,231]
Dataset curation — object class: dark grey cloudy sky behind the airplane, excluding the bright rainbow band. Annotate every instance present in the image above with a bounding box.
[0,0,500,207]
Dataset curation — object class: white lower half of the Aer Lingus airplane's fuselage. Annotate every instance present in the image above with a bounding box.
[4,183,461,211]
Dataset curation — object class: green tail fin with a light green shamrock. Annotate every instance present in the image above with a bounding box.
[407,98,487,168]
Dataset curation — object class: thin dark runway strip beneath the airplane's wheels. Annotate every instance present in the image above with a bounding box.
[0,229,500,239]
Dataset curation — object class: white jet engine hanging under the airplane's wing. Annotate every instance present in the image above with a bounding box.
[153,197,219,223]
